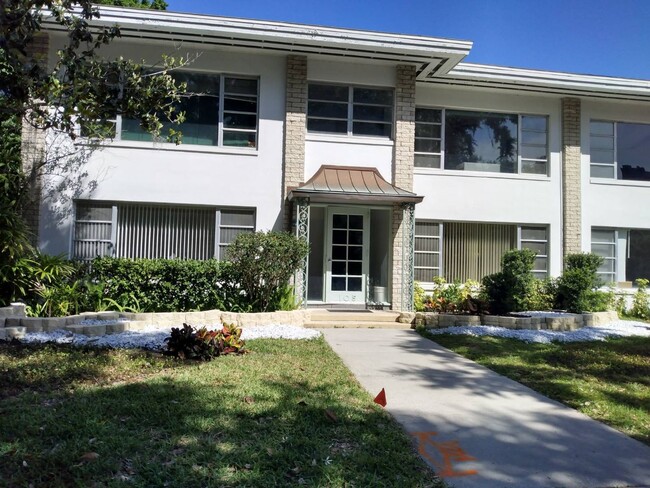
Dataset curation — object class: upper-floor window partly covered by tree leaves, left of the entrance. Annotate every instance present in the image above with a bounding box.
[109,71,259,148]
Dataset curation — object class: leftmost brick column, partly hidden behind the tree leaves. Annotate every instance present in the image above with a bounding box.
[20,32,50,246]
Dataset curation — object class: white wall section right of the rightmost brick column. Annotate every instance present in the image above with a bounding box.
[581,100,650,251]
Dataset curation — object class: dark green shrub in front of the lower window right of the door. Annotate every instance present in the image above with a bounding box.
[482,249,536,314]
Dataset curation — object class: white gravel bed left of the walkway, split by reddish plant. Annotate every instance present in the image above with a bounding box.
[21,325,321,350]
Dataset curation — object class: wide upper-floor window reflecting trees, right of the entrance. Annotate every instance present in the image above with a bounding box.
[415,108,548,175]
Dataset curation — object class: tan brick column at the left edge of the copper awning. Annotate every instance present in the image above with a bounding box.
[282,55,307,230]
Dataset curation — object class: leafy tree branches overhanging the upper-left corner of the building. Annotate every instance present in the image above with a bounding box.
[0,0,184,138]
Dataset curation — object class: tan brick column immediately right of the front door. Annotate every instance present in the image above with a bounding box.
[391,65,416,310]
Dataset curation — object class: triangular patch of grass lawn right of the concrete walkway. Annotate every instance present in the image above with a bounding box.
[425,333,650,445]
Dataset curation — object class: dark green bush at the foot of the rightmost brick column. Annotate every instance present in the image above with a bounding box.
[556,253,613,313]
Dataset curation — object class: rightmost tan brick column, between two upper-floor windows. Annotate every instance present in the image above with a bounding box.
[562,98,582,256]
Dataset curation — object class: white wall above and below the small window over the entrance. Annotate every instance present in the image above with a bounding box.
[305,59,395,181]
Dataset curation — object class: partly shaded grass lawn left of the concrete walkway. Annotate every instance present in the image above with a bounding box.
[0,339,444,487]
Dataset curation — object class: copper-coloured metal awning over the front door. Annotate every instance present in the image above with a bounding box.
[289,165,424,204]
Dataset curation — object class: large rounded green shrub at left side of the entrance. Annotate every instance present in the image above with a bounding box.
[228,232,309,312]
